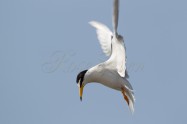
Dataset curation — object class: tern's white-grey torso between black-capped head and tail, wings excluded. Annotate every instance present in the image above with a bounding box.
[84,62,133,91]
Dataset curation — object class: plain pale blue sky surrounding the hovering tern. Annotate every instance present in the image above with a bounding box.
[0,0,187,124]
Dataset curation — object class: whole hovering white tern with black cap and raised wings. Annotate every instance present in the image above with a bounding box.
[76,0,135,113]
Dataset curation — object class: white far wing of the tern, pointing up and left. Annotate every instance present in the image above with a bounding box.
[89,21,112,56]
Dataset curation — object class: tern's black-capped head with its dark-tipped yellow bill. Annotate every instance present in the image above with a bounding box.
[76,70,88,101]
